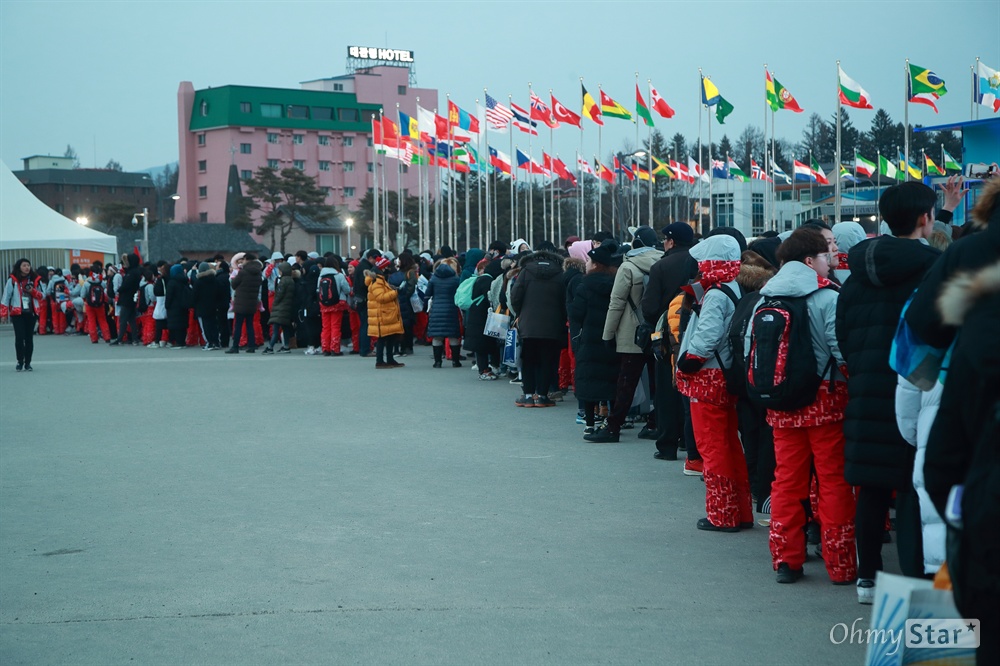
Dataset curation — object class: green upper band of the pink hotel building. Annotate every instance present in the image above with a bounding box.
[190,86,382,132]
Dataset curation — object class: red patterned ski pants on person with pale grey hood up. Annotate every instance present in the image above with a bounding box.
[691,400,752,527]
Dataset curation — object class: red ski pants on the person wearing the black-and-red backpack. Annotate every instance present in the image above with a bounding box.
[768,421,858,583]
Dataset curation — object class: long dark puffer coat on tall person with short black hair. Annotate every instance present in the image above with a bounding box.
[837,236,940,488]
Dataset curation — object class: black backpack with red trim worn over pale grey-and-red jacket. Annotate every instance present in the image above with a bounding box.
[748,296,834,412]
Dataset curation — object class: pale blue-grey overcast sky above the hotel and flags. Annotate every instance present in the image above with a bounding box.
[0,0,1000,170]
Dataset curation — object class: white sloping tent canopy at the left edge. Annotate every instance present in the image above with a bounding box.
[0,162,118,256]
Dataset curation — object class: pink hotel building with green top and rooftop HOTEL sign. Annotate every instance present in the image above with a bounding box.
[175,66,438,251]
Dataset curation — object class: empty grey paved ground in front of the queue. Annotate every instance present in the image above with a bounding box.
[0,328,893,664]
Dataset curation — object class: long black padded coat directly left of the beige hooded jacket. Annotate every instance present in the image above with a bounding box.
[569,272,618,402]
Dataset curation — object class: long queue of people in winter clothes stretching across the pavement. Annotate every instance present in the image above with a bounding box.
[2,174,1000,663]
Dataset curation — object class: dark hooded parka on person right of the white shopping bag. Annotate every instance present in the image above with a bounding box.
[510,250,567,342]
